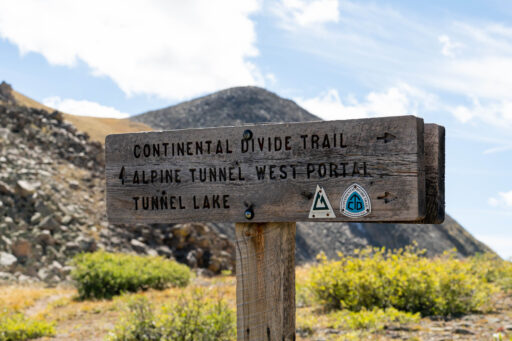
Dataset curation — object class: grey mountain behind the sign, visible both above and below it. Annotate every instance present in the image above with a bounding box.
[133,87,492,261]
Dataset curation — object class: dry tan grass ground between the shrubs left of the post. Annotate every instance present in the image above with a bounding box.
[0,276,236,340]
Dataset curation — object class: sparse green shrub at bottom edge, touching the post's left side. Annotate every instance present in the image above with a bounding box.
[109,291,235,341]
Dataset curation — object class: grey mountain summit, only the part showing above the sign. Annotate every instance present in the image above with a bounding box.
[131,86,320,130]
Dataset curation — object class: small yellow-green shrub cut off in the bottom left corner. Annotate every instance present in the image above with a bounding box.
[0,311,55,341]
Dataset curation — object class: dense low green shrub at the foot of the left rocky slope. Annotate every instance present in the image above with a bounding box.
[71,251,192,299]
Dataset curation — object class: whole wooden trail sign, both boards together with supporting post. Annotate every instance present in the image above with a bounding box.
[105,116,444,340]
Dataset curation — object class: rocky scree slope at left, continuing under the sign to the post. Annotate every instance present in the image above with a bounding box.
[0,83,234,283]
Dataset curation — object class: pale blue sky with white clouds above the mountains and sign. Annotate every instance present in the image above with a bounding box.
[0,0,512,257]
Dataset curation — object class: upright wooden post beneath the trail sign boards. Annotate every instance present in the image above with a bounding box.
[235,223,296,341]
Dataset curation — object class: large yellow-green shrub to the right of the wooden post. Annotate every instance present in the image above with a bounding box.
[310,248,495,316]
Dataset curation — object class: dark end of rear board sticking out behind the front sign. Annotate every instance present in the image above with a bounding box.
[419,124,445,224]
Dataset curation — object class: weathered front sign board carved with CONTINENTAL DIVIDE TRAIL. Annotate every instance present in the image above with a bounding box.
[105,116,426,223]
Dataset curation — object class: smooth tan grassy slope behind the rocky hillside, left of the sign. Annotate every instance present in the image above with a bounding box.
[13,91,152,144]
